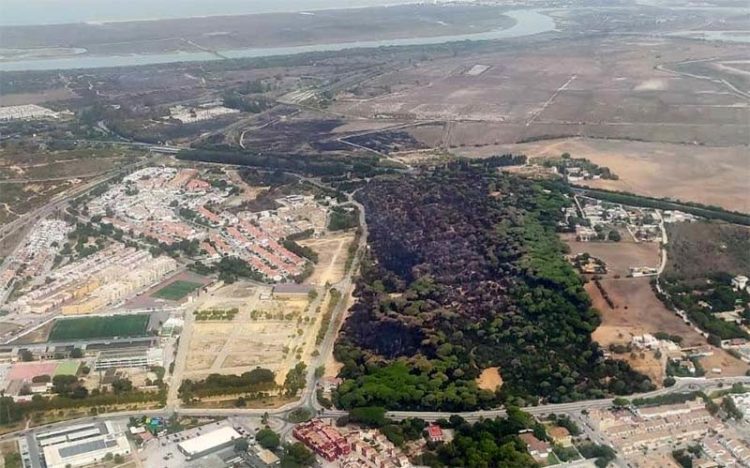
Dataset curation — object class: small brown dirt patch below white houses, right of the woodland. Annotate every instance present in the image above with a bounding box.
[567,238,659,277]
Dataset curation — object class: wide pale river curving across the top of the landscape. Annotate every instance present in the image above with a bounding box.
[0,9,555,71]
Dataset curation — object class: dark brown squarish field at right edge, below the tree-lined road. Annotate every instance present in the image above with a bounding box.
[665,222,750,279]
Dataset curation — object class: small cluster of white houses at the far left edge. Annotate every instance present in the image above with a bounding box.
[0,219,72,304]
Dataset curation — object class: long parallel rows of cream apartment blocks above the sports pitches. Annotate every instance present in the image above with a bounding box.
[8,243,177,314]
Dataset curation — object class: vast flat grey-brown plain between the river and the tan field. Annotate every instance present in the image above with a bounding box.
[340,37,750,148]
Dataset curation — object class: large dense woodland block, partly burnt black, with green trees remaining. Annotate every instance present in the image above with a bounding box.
[335,163,653,411]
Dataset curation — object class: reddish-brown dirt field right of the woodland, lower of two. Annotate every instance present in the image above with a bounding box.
[585,278,706,347]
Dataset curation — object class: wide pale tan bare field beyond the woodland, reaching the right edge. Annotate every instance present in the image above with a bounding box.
[459,138,750,212]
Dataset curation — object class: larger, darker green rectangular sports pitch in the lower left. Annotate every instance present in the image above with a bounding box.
[49,314,149,341]
